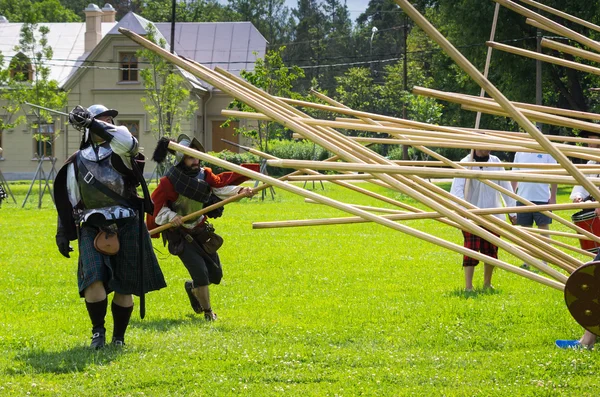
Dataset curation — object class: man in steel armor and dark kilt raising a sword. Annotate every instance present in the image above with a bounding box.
[54,105,166,349]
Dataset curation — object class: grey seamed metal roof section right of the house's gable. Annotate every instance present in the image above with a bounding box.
[155,22,267,75]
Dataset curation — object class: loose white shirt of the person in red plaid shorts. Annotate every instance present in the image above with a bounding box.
[450,154,516,220]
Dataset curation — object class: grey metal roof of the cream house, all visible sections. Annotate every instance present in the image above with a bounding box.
[0,12,267,89]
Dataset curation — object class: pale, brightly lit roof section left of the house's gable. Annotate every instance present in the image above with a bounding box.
[0,22,116,86]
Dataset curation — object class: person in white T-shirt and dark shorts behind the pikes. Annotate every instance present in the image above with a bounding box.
[512,152,557,269]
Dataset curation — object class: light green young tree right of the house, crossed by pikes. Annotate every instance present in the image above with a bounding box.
[227,47,304,152]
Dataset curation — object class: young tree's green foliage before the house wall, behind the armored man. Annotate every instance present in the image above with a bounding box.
[137,23,198,139]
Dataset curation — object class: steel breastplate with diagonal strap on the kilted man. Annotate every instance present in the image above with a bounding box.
[77,147,131,210]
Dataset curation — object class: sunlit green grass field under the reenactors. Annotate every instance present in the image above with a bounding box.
[0,183,600,396]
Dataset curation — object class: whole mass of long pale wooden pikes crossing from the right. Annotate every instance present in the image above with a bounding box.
[120,0,600,300]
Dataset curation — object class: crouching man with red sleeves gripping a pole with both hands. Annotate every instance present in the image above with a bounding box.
[147,134,259,321]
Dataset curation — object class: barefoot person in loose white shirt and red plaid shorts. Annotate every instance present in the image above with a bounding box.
[450,150,516,291]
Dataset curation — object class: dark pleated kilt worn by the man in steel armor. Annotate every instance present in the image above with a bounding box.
[77,216,167,297]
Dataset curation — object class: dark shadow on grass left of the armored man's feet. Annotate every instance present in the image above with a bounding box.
[7,346,127,375]
